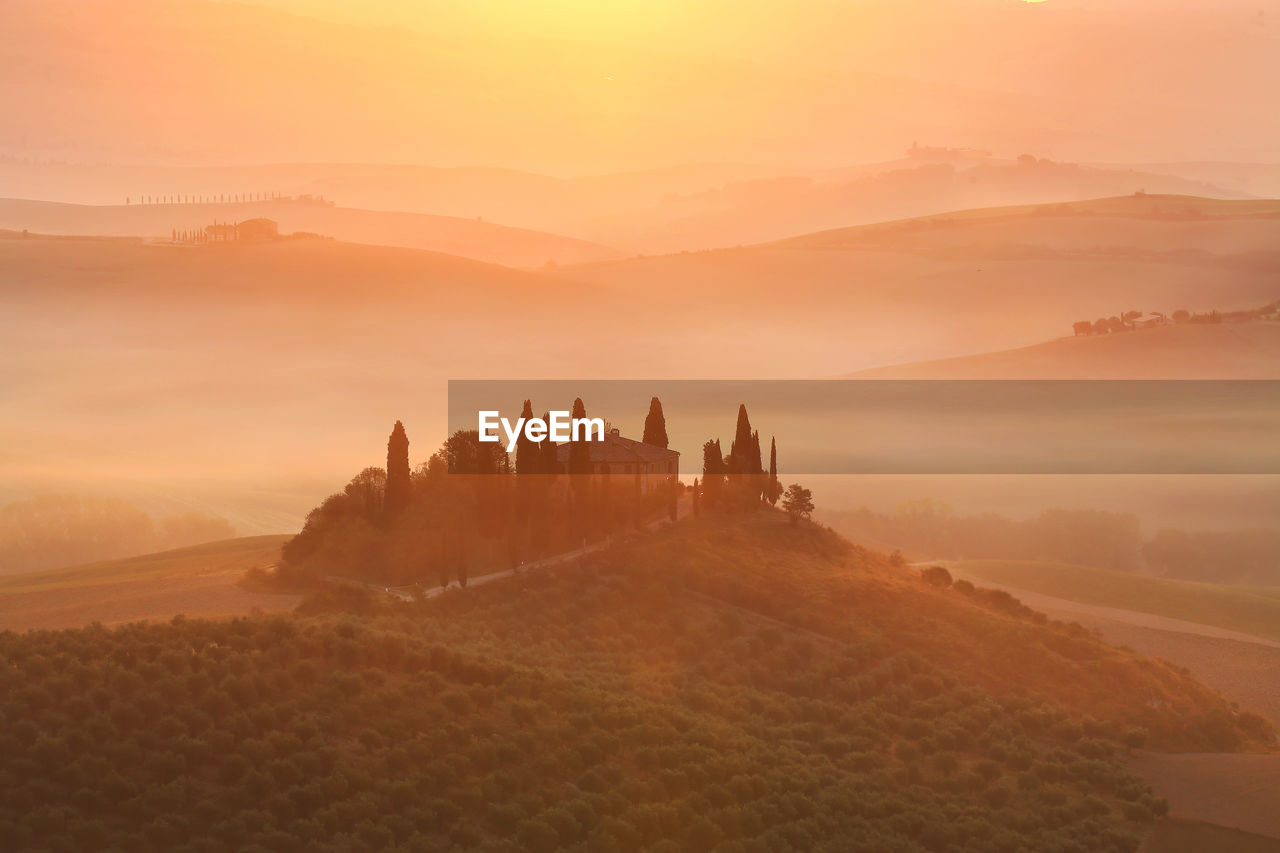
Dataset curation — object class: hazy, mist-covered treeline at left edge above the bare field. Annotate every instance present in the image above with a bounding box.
[0,494,236,574]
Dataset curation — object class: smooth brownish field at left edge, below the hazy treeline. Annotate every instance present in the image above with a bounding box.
[0,535,300,630]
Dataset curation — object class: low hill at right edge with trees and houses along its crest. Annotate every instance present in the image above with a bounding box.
[850,323,1280,379]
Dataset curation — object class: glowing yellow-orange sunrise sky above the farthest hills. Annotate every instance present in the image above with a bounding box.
[0,0,1280,175]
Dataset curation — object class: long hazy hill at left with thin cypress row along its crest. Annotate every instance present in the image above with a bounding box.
[0,199,621,266]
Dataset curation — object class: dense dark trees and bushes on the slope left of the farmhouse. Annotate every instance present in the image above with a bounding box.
[280,400,680,585]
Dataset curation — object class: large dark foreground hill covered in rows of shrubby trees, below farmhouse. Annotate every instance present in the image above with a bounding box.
[0,514,1262,853]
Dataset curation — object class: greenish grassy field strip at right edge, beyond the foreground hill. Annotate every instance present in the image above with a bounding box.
[950,560,1280,640]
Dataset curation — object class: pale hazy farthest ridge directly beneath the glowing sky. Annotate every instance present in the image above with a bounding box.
[0,156,1249,253]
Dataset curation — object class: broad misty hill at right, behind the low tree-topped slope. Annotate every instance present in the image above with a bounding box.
[561,196,1280,377]
